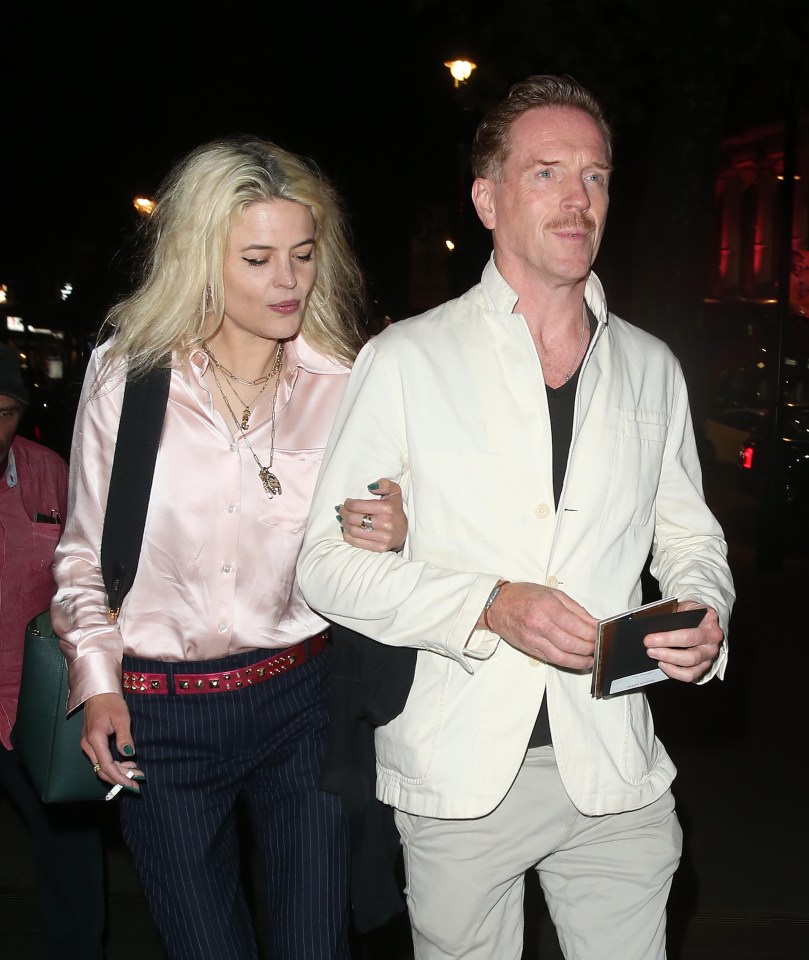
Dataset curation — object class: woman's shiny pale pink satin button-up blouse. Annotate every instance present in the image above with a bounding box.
[51,337,349,710]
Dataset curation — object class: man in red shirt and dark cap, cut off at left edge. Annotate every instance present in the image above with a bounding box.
[0,343,104,960]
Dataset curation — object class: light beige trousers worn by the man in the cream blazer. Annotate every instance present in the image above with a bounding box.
[396,747,682,960]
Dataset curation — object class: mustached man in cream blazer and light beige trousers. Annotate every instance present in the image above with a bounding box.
[299,76,734,960]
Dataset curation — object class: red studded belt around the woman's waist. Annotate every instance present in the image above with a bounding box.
[123,630,329,696]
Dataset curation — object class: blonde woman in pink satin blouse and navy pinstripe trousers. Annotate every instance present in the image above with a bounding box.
[52,138,406,960]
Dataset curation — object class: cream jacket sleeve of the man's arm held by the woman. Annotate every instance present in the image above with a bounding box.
[298,341,497,671]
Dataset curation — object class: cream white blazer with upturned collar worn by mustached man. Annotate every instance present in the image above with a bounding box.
[298,259,734,819]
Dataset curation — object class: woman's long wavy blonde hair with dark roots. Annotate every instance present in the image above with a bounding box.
[99,136,366,376]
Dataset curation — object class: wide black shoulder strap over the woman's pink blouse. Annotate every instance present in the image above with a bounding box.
[101,360,171,621]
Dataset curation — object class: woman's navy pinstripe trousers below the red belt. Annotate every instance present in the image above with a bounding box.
[121,647,350,960]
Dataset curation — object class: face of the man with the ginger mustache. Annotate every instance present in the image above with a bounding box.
[473,107,610,290]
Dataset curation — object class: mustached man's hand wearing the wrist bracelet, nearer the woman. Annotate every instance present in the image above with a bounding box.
[477,583,597,670]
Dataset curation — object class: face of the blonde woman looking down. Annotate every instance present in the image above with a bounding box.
[222,200,317,343]
